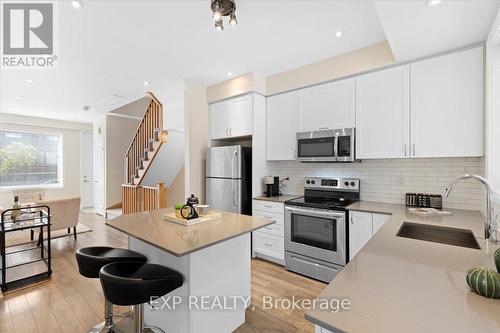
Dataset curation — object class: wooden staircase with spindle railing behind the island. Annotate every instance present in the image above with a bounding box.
[122,92,168,214]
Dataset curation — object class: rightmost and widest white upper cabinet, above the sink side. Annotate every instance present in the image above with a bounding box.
[411,47,484,157]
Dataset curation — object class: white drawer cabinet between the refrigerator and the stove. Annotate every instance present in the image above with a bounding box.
[252,200,285,265]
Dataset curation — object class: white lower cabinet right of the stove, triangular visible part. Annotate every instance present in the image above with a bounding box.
[349,211,389,260]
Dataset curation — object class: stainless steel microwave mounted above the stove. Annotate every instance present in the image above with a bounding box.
[297,128,356,162]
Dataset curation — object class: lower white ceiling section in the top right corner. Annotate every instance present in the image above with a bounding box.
[375,0,499,61]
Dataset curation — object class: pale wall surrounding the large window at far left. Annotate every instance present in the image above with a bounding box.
[0,113,92,208]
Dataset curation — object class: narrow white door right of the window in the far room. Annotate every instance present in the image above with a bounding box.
[80,132,94,208]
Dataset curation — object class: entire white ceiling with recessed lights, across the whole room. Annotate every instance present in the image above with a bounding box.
[0,0,498,127]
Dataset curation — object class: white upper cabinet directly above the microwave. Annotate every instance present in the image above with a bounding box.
[298,78,356,132]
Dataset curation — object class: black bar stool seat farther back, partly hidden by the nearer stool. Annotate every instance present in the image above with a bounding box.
[76,246,148,279]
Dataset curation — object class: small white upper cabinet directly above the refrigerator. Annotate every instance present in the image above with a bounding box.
[209,94,253,140]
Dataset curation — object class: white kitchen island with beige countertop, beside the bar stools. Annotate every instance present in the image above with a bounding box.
[106,208,274,333]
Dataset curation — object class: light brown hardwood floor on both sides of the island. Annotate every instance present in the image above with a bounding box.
[0,213,326,333]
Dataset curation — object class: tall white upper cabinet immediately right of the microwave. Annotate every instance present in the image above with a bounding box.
[356,65,410,159]
